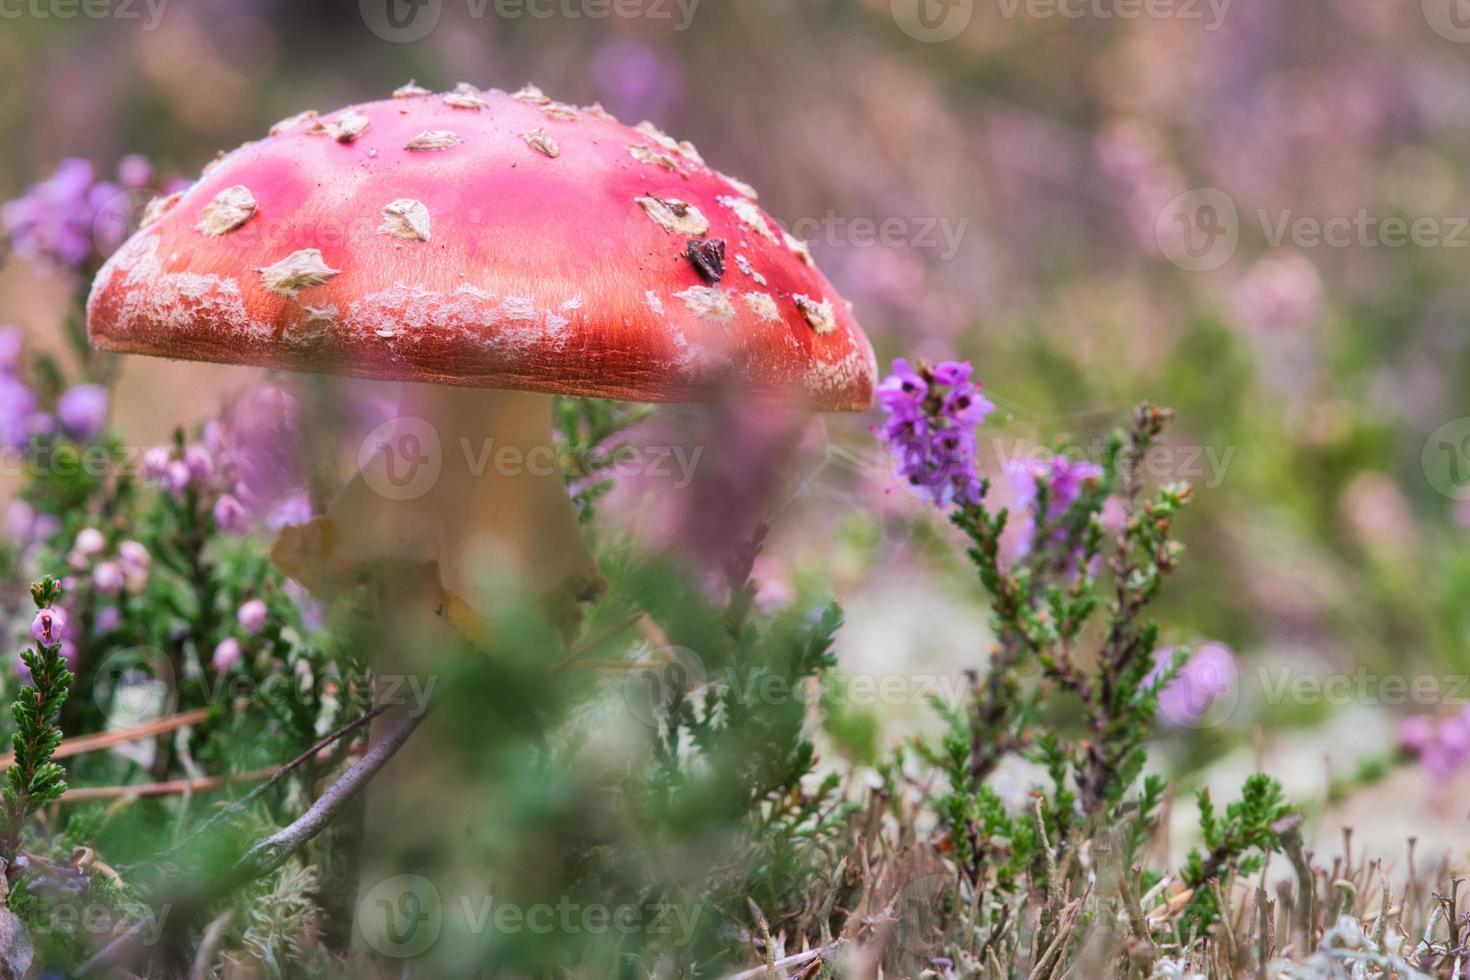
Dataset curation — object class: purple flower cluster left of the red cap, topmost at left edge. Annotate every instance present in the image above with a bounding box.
[0,156,153,269]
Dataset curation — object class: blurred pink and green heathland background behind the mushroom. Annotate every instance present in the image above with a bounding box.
[0,0,1470,854]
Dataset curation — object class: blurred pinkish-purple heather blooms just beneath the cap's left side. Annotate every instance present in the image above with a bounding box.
[143,385,312,533]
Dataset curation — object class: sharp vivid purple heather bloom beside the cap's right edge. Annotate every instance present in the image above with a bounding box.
[878,359,995,507]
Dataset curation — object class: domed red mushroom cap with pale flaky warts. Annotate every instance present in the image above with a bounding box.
[87,84,876,410]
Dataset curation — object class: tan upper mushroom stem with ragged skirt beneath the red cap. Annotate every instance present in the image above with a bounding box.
[272,383,601,636]
